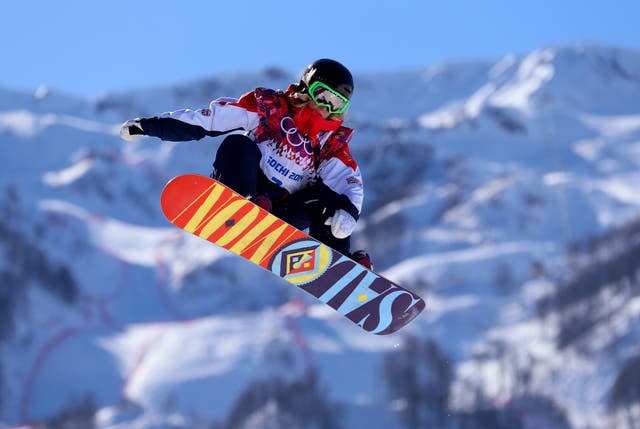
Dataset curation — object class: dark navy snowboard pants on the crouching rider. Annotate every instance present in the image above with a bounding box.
[211,134,351,252]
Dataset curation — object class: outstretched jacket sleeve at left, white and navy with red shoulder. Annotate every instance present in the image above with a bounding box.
[140,93,259,141]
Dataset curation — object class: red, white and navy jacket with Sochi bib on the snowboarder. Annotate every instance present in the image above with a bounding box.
[141,88,363,214]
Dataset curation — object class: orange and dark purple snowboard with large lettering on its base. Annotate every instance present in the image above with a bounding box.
[160,174,425,335]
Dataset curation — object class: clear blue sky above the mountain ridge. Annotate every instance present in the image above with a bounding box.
[0,0,640,97]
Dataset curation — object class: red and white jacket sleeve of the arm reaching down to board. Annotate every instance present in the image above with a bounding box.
[318,130,364,220]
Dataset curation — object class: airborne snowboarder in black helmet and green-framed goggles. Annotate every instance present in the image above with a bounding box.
[120,59,372,268]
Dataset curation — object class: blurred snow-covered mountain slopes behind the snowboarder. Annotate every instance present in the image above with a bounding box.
[0,46,640,429]
